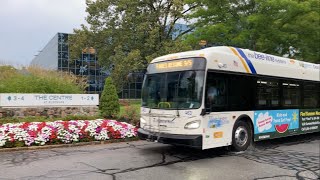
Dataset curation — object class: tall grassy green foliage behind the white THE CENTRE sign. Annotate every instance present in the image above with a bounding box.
[0,67,86,94]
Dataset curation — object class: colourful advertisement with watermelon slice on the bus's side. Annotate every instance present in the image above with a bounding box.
[254,109,320,141]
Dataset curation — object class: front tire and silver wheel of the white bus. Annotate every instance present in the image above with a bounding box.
[232,120,252,151]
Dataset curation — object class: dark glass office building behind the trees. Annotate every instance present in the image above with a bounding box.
[31,33,144,99]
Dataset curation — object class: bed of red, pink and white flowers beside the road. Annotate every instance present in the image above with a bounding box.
[0,119,137,147]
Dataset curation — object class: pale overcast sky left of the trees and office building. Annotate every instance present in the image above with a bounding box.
[0,0,86,66]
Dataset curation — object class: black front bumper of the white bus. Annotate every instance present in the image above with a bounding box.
[138,128,202,149]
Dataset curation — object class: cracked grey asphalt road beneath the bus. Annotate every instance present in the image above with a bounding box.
[0,133,320,180]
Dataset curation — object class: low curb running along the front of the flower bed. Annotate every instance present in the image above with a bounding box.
[0,138,139,152]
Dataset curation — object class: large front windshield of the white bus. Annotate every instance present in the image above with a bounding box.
[142,70,204,109]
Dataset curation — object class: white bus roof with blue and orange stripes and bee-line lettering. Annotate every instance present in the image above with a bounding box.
[151,46,320,81]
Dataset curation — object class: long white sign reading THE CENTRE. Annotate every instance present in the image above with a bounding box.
[0,94,99,107]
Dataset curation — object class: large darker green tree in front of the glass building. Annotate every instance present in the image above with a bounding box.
[70,0,196,90]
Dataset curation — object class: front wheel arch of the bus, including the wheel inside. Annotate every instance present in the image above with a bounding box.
[232,115,254,151]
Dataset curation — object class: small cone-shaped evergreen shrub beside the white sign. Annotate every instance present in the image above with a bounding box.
[99,77,120,118]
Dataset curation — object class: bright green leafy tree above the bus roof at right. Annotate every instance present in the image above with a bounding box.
[187,0,320,63]
